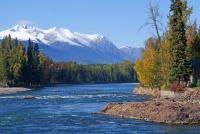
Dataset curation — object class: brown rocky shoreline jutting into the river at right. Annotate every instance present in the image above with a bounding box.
[100,87,200,125]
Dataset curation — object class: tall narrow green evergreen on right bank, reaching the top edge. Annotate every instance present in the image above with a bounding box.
[169,0,191,85]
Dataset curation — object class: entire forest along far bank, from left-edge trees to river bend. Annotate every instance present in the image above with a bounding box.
[0,36,136,87]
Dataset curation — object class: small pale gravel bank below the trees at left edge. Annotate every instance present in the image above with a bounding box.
[0,87,32,95]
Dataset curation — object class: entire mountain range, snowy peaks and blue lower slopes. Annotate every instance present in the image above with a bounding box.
[0,25,143,64]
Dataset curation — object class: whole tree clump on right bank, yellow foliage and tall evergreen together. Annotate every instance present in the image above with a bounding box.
[134,0,200,89]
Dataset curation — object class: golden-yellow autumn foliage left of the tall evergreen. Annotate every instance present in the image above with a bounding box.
[134,38,170,88]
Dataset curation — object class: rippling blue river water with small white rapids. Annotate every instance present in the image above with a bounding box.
[0,84,200,134]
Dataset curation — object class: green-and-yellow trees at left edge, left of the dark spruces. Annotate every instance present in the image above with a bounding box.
[0,35,26,86]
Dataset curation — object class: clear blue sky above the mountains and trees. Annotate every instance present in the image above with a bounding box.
[0,0,200,47]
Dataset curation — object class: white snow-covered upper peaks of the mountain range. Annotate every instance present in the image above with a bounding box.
[0,24,110,45]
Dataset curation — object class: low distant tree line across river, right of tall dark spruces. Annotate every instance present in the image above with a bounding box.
[43,60,136,83]
